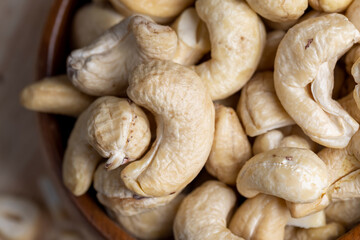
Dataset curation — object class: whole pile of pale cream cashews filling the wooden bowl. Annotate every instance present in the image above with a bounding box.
[21,0,360,240]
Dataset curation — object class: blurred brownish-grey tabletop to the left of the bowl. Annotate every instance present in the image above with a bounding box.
[0,0,101,239]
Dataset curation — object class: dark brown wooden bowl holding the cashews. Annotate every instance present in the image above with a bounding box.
[37,0,360,240]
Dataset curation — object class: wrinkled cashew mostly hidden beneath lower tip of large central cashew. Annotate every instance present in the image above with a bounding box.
[94,164,178,216]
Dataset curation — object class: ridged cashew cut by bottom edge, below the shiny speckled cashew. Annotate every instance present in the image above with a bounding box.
[229,194,289,240]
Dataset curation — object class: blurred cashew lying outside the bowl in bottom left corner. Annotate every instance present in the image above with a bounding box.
[0,194,41,240]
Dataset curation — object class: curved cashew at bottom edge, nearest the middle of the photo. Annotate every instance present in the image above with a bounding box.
[173,181,243,240]
